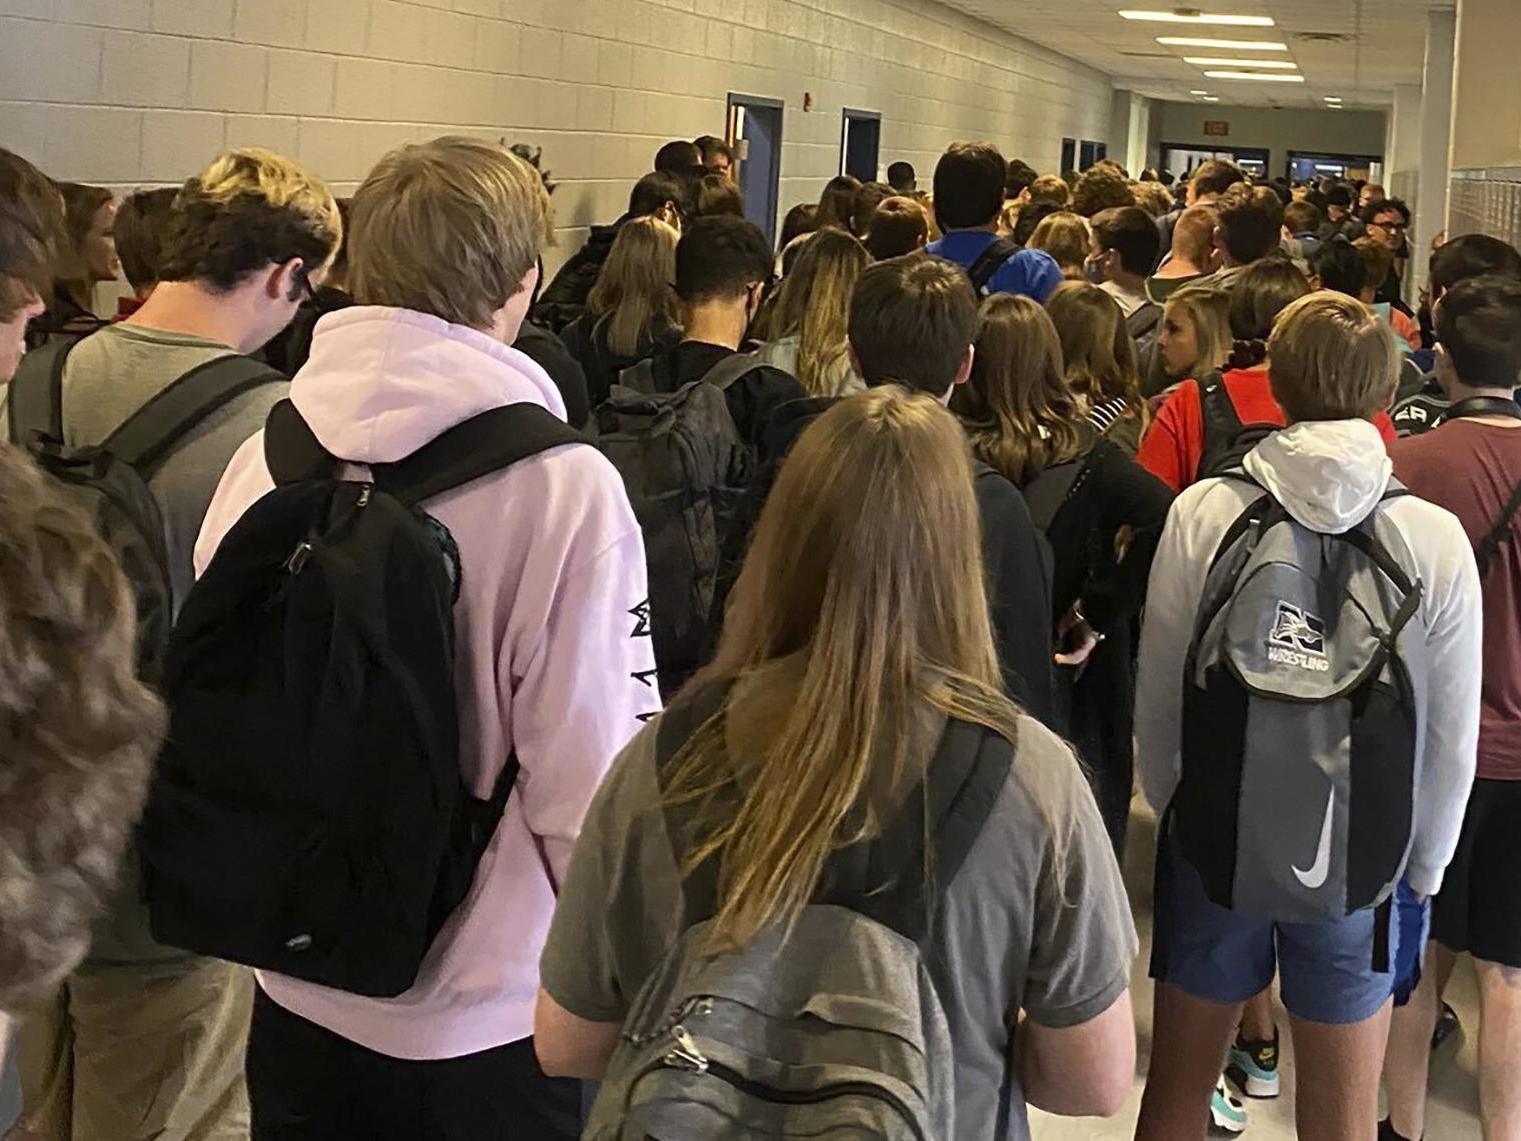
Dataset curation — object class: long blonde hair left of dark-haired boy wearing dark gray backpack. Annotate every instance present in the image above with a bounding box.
[586,218,681,356]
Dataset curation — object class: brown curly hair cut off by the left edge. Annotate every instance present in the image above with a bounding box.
[0,446,164,1010]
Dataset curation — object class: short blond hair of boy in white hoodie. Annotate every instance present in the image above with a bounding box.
[1267,291,1399,423]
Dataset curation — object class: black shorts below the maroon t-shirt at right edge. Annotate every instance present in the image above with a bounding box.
[1431,780,1521,968]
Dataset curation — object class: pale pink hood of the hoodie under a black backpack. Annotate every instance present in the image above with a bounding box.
[291,306,566,464]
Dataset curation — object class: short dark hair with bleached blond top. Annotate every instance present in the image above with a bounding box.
[158,148,344,292]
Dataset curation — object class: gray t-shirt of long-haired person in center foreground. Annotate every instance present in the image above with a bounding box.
[540,717,1138,1141]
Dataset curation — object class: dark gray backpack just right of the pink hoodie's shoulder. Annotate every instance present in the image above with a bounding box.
[596,353,754,700]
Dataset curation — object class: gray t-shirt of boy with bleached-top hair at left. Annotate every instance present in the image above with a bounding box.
[64,324,289,963]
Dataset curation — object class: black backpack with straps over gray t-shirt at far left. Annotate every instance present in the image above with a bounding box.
[8,341,286,683]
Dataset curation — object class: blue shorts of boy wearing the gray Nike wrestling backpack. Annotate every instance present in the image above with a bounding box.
[1151,844,1413,1025]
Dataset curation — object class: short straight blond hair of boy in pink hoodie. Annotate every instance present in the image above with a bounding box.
[348,135,551,329]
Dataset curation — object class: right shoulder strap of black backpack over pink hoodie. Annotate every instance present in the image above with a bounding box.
[371,402,589,505]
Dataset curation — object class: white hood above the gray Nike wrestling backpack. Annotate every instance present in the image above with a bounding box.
[1244,420,1395,536]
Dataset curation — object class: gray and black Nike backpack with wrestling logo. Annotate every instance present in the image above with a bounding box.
[1168,475,1427,931]
